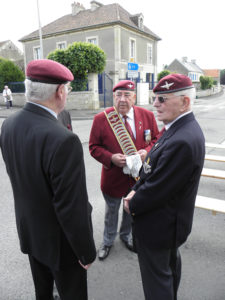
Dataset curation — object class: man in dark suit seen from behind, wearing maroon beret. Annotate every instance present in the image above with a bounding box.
[1,59,96,300]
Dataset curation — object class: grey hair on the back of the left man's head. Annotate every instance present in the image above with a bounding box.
[25,79,59,102]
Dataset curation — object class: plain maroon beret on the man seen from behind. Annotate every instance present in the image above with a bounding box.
[26,59,74,84]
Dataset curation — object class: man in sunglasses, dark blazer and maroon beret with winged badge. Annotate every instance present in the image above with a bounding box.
[124,74,205,300]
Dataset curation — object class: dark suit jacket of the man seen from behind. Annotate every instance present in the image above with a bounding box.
[1,103,96,269]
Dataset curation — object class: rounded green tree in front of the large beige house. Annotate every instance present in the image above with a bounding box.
[48,42,106,91]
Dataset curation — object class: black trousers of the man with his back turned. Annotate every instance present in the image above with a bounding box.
[29,255,88,300]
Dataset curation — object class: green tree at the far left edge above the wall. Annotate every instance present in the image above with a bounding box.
[0,57,25,91]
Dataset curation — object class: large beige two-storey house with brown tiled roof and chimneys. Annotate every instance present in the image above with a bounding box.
[20,1,160,88]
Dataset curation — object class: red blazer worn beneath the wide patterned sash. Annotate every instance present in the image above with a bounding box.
[89,106,159,198]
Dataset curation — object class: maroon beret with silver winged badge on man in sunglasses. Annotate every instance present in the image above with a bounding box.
[153,74,194,94]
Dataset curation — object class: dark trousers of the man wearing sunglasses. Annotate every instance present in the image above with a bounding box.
[136,241,181,300]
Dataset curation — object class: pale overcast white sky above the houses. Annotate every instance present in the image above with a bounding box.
[0,0,225,71]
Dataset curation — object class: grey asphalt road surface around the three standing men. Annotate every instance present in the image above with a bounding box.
[0,96,225,300]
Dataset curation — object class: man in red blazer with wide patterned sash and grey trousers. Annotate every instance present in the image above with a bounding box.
[89,80,158,260]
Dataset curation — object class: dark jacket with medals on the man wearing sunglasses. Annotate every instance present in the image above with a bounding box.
[129,113,205,248]
